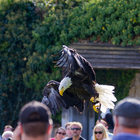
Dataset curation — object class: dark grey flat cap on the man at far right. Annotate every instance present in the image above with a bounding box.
[113,98,140,119]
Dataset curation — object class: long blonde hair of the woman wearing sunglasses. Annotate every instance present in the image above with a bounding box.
[93,123,108,140]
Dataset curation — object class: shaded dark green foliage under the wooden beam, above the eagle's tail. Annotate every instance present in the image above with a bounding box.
[95,70,138,101]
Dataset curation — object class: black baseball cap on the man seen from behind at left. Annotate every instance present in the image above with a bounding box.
[19,101,52,124]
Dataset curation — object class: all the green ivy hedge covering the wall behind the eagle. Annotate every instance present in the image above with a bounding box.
[0,0,139,132]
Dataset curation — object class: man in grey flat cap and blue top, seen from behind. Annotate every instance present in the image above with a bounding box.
[104,98,140,140]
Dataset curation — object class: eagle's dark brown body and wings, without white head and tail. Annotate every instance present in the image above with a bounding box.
[43,45,99,113]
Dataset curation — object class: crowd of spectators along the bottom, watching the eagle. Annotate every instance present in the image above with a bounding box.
[1,98,140,140]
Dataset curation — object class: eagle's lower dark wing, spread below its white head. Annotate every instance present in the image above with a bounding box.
[42,80,84,115]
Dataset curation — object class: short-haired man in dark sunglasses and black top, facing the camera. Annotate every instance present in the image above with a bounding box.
[67,122,85,140]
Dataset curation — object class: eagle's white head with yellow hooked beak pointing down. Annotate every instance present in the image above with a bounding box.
[59,77,72,96]
